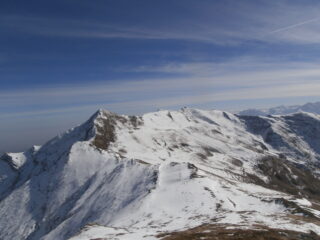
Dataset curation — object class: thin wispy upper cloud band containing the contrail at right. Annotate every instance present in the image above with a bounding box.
[1,1,320,45]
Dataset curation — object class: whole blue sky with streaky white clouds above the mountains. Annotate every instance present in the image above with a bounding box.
[0,0,320,153]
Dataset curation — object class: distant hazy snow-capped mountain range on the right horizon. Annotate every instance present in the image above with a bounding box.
[239,102,320,116]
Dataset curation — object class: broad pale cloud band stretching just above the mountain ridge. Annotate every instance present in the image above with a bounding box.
[0,59,320,118]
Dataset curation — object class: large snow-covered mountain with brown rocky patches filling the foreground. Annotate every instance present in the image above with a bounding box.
[0,108,320,240]
